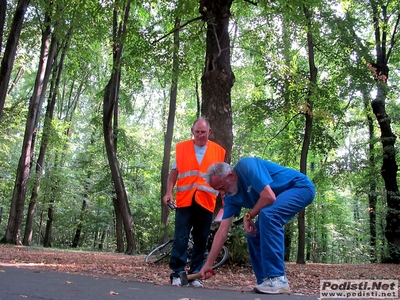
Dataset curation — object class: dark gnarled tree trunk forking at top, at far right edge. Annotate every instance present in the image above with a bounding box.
[369,1,400,263]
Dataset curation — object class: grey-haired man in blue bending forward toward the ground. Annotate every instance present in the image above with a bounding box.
[201,157,315,294]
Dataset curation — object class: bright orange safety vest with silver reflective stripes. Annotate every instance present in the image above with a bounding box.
[175,140,225,212]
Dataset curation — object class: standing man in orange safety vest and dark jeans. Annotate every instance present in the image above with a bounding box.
[163,118,225,287]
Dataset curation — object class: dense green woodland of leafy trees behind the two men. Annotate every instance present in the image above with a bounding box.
[0,0,400,263]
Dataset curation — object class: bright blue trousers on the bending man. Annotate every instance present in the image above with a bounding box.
[247,185,315,284]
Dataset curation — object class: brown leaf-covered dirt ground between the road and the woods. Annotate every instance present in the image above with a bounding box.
[0,245,400,295]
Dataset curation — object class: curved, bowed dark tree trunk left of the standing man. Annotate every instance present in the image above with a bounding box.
[103,0,137,254]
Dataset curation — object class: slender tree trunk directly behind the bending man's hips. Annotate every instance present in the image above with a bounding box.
[296,7,317,264]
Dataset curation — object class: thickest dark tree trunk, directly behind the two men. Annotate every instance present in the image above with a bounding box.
[199,0,235,162]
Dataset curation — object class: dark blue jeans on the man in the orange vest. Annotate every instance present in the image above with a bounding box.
[169,199,213,277]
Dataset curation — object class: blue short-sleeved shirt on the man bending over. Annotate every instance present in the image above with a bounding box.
[222,157,313,219]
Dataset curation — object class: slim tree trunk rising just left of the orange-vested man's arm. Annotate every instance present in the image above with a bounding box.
[158,18,181,244]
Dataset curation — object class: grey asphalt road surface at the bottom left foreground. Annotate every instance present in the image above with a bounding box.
[0,265,318,300]
